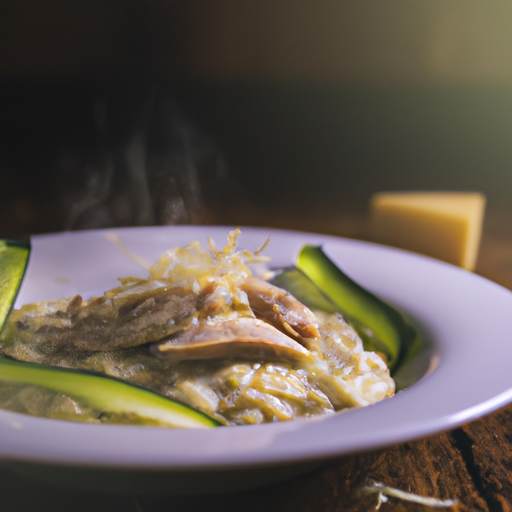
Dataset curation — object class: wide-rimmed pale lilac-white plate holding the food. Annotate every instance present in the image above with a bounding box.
[0,226,512,492]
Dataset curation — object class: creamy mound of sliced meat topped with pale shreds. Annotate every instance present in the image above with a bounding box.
[0,230,396,425]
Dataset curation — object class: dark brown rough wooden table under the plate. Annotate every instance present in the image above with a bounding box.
[0,204,512,512]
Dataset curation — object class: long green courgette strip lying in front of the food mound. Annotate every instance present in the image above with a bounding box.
[0,357,219,428]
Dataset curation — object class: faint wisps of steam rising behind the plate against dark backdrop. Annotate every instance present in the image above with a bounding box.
[65,96,223,230]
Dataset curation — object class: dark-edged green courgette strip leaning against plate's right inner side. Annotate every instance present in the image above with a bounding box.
[295,245,415,370]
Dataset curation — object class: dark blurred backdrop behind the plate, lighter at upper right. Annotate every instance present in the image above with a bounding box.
[0,0,512,237]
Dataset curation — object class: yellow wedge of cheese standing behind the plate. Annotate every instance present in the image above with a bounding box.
[370,192,485,270]
